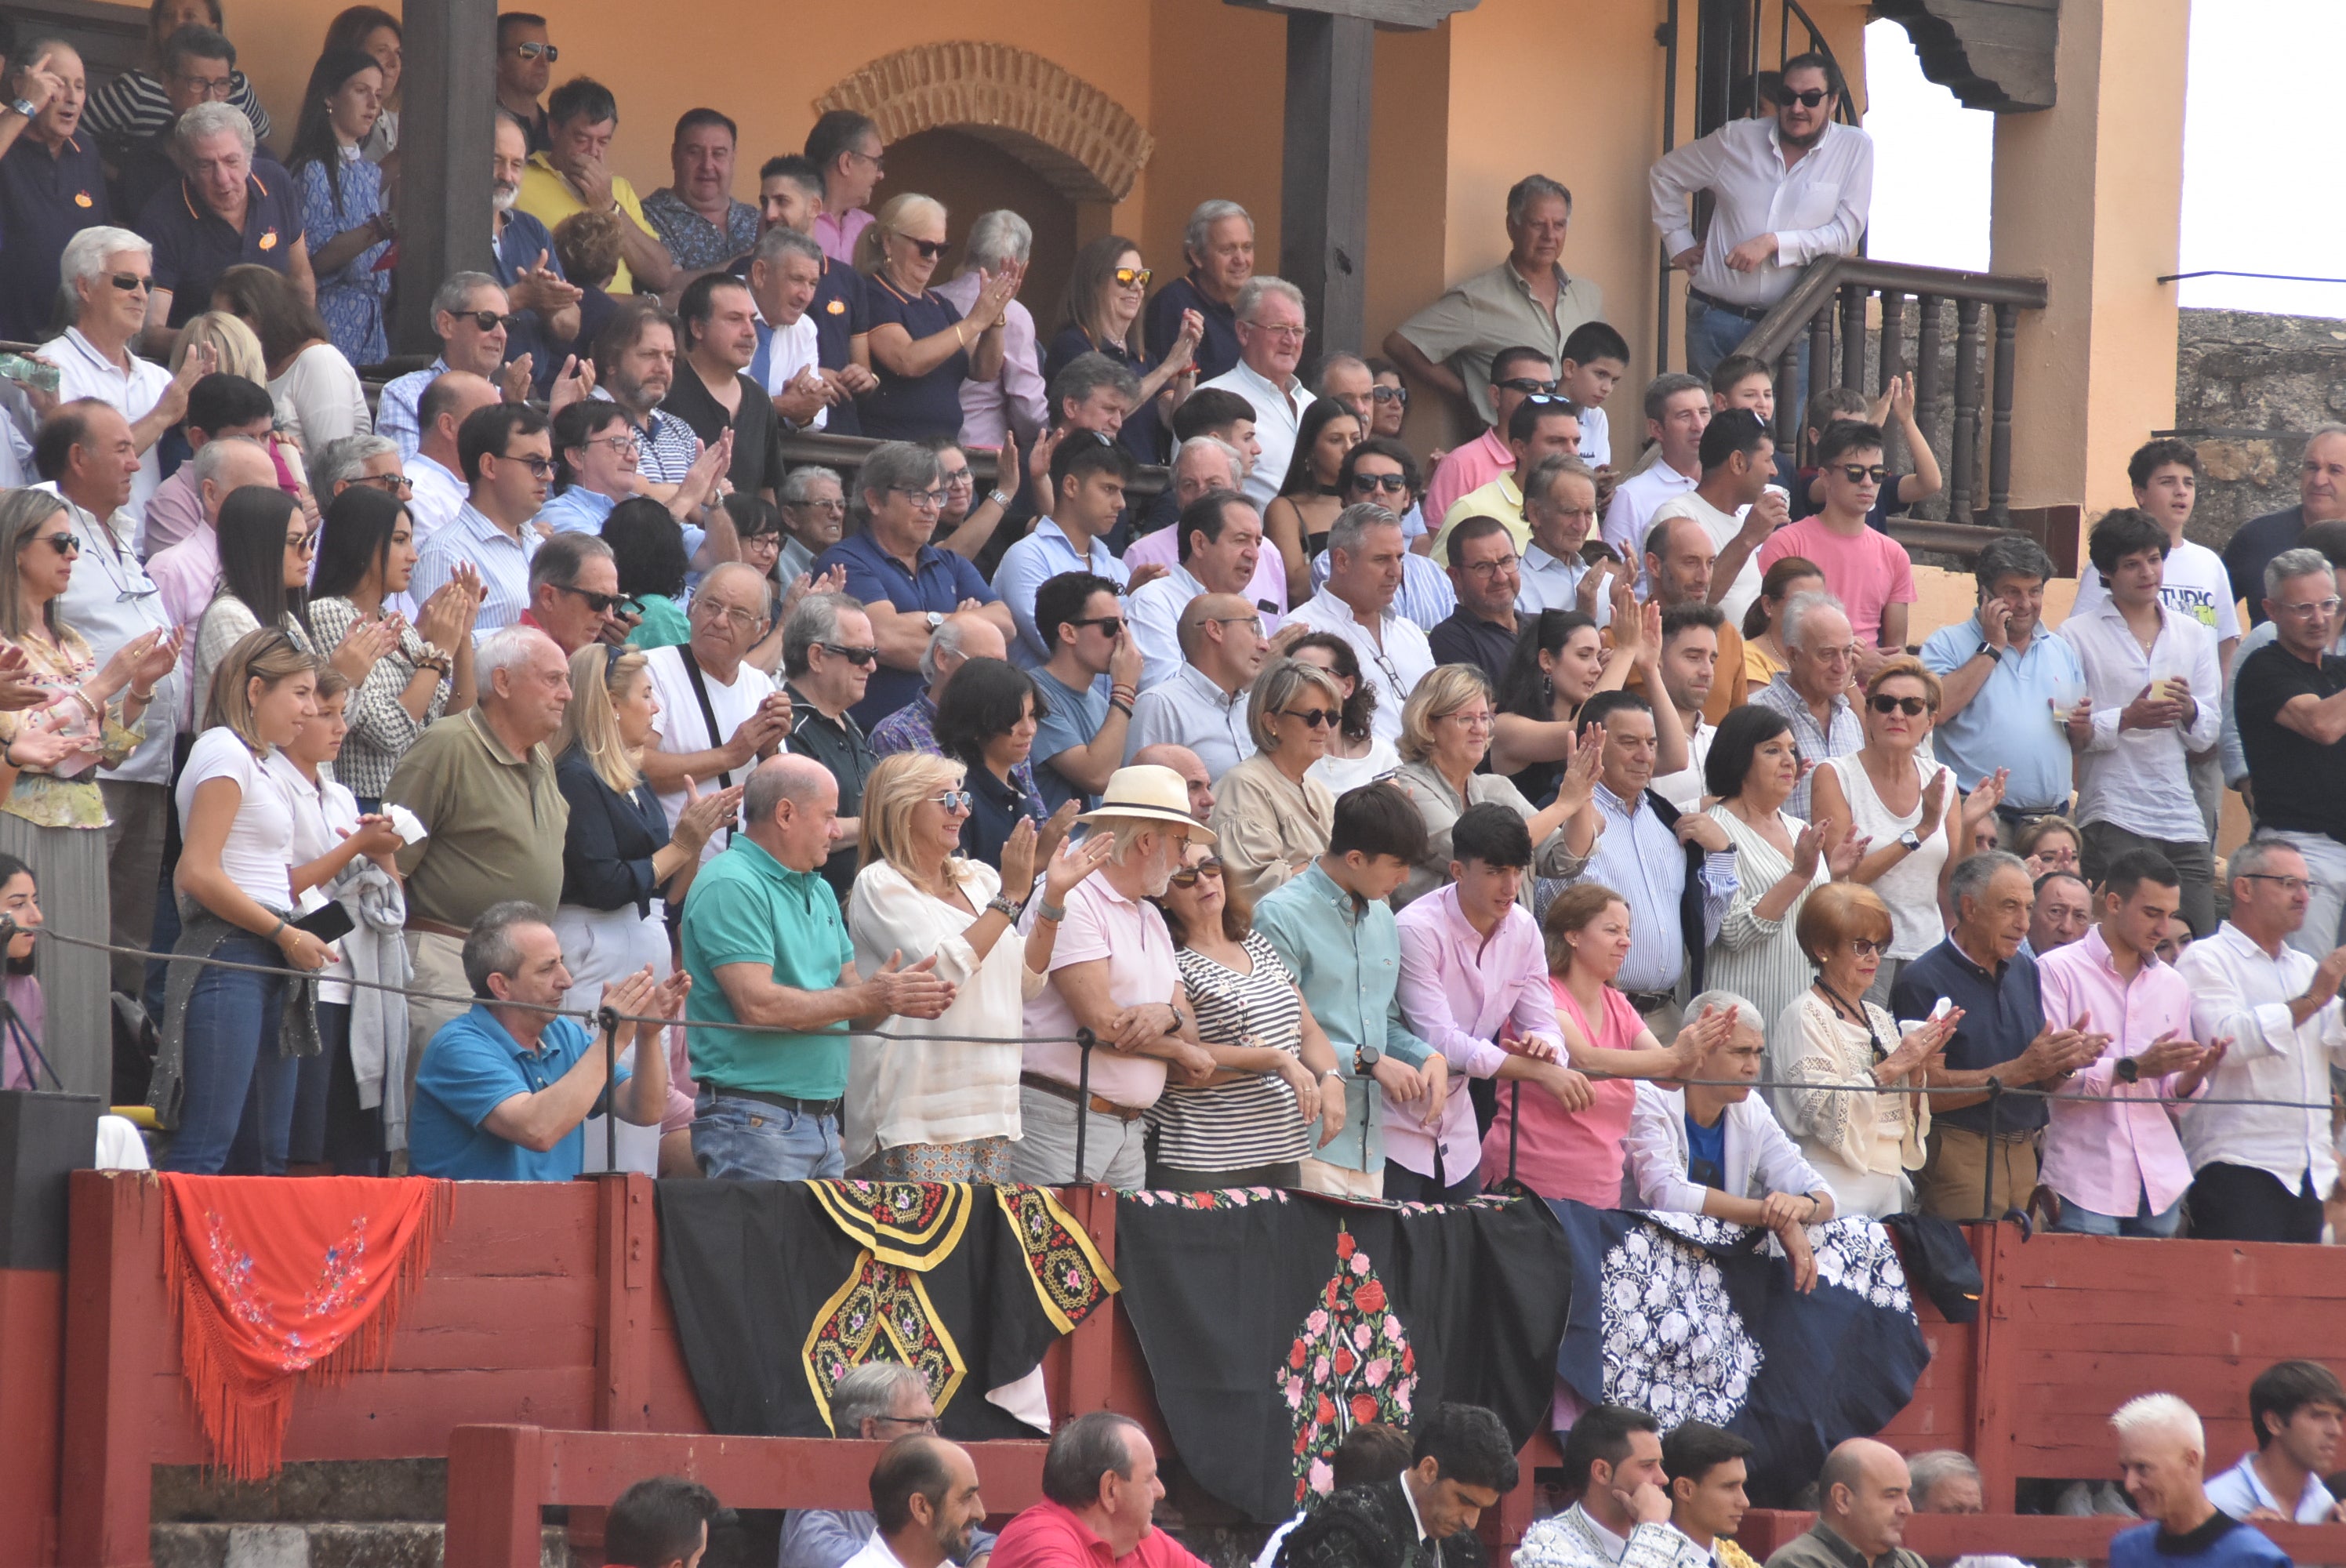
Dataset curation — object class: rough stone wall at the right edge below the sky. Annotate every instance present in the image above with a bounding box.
[2175,310,2346,547]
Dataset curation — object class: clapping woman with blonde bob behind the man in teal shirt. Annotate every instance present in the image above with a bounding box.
[1393,664,1605,909]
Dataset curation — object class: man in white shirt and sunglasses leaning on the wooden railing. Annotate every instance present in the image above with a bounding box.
[1647,54,1875,380]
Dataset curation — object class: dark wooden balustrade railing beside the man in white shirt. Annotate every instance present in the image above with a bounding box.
[1738,256,2046,528]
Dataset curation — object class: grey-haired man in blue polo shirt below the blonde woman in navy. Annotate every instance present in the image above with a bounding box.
[814,441,1019,730]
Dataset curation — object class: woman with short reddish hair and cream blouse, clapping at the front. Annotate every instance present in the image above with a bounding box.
[1769,883,1963,1218]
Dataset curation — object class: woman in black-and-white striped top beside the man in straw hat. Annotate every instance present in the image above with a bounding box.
[1149,843,1344,1192]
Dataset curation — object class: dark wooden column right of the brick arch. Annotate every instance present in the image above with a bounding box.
[1279,12,1377,354]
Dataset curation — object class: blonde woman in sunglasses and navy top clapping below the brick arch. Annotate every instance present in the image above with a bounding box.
[856,191,1026,441]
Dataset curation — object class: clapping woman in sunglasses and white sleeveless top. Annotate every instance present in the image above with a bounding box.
[1809,655,1999,1002]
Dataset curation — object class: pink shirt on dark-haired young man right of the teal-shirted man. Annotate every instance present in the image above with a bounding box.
[1384,883,1565,1185]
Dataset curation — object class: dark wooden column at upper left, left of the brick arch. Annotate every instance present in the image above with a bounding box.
[392,0,497,354]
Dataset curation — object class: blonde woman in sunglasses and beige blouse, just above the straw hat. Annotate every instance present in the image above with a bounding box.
[1208,659,1344,904]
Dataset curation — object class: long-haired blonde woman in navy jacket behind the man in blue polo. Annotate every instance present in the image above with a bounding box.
[554,643,741,1174]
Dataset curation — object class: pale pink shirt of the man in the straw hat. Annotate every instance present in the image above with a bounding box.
[1019,876,1180,1110]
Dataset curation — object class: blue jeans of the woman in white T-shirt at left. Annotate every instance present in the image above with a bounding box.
[162,937,300,1176]
